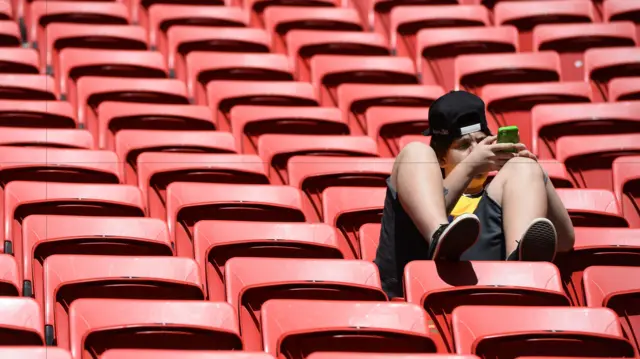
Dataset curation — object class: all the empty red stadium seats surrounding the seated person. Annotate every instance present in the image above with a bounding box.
[0,0,640,359]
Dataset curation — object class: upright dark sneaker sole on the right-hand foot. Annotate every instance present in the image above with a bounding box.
[520,219,557,262]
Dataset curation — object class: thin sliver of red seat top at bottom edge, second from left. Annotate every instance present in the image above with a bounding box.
[101,349,274,359]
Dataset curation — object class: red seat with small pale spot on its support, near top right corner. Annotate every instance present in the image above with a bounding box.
[533,21,637,81]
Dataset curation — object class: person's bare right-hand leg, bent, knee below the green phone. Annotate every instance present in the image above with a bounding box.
[487,157,555,257]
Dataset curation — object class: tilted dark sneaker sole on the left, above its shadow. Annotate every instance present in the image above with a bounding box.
[433,215,480,261]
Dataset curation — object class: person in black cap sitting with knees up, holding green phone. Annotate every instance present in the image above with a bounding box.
[374,91,575,298]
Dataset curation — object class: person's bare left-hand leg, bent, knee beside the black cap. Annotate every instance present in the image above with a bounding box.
[391,142,449,238]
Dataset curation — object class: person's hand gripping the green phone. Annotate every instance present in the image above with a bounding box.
[462,136,533,176]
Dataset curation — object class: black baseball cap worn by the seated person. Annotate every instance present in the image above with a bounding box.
[422,91,491,139]
